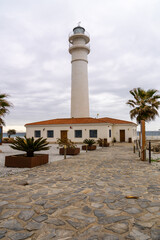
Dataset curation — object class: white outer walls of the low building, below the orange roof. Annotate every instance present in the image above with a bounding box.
[26,123,137,143]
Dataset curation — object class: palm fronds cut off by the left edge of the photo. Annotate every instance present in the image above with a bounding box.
[0,93,13,126]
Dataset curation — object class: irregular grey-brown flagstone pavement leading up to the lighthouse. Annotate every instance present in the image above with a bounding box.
[0,144,160,240]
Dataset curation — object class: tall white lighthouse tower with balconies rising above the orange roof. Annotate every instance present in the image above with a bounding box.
[69,26,90,118]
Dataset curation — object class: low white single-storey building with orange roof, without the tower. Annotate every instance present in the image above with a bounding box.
[26,118,137,143]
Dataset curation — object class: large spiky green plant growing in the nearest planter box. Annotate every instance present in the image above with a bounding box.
[10,137,50,157]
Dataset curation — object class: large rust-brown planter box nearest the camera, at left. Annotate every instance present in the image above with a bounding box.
[5,154,48,168]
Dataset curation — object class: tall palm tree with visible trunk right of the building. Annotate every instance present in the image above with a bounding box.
[127,88,160,159]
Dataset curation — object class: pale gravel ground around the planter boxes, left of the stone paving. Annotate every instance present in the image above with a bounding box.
[0,143,85,177]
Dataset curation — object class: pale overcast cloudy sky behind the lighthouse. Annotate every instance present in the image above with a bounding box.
[0,0,160,131]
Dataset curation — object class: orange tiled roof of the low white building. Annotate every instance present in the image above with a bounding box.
[25,118,134,126]
